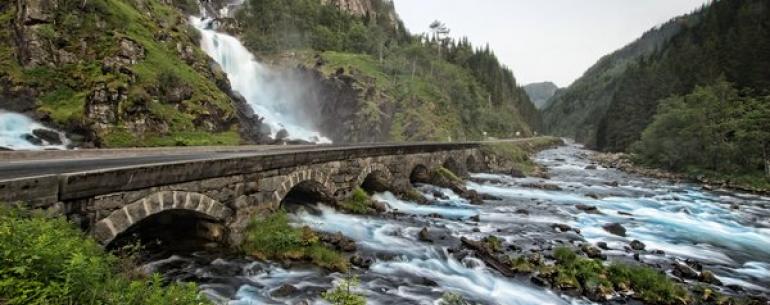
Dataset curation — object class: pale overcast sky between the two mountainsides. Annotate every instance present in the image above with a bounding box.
[394,0,707,87]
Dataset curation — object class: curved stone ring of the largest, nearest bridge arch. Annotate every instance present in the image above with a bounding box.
[93,191,233,246]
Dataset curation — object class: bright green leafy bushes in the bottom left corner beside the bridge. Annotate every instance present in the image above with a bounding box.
[0,208,209,305]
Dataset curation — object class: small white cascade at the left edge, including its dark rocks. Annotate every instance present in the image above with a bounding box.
[0,109,70,150]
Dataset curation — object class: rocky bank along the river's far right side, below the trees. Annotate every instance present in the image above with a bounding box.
[591,152,770,195]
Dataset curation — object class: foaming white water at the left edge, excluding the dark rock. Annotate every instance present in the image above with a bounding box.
[0,110,69,150]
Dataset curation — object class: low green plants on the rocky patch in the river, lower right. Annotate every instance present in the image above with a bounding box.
[553,247,691,304]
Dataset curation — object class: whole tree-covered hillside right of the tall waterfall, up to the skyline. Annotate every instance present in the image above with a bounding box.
[236,0,542,141]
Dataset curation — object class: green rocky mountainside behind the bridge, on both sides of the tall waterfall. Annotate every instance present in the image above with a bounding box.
[0,0,541,147]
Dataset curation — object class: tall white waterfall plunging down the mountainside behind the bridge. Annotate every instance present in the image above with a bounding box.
[190,17,331,143]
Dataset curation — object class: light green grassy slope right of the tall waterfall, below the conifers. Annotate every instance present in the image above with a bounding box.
[322,52,531,141]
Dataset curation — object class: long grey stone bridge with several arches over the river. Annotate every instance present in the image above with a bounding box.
[0,142,510,245]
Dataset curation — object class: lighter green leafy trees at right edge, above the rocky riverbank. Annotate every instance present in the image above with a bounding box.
[633,82,770,189]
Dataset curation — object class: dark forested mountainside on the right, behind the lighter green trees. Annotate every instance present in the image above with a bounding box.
[544,0,770,151]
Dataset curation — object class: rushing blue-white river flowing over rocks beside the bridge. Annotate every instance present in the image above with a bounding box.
[140,145,770,305]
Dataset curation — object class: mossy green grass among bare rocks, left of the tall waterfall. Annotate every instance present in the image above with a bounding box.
[0,0,240,147]
